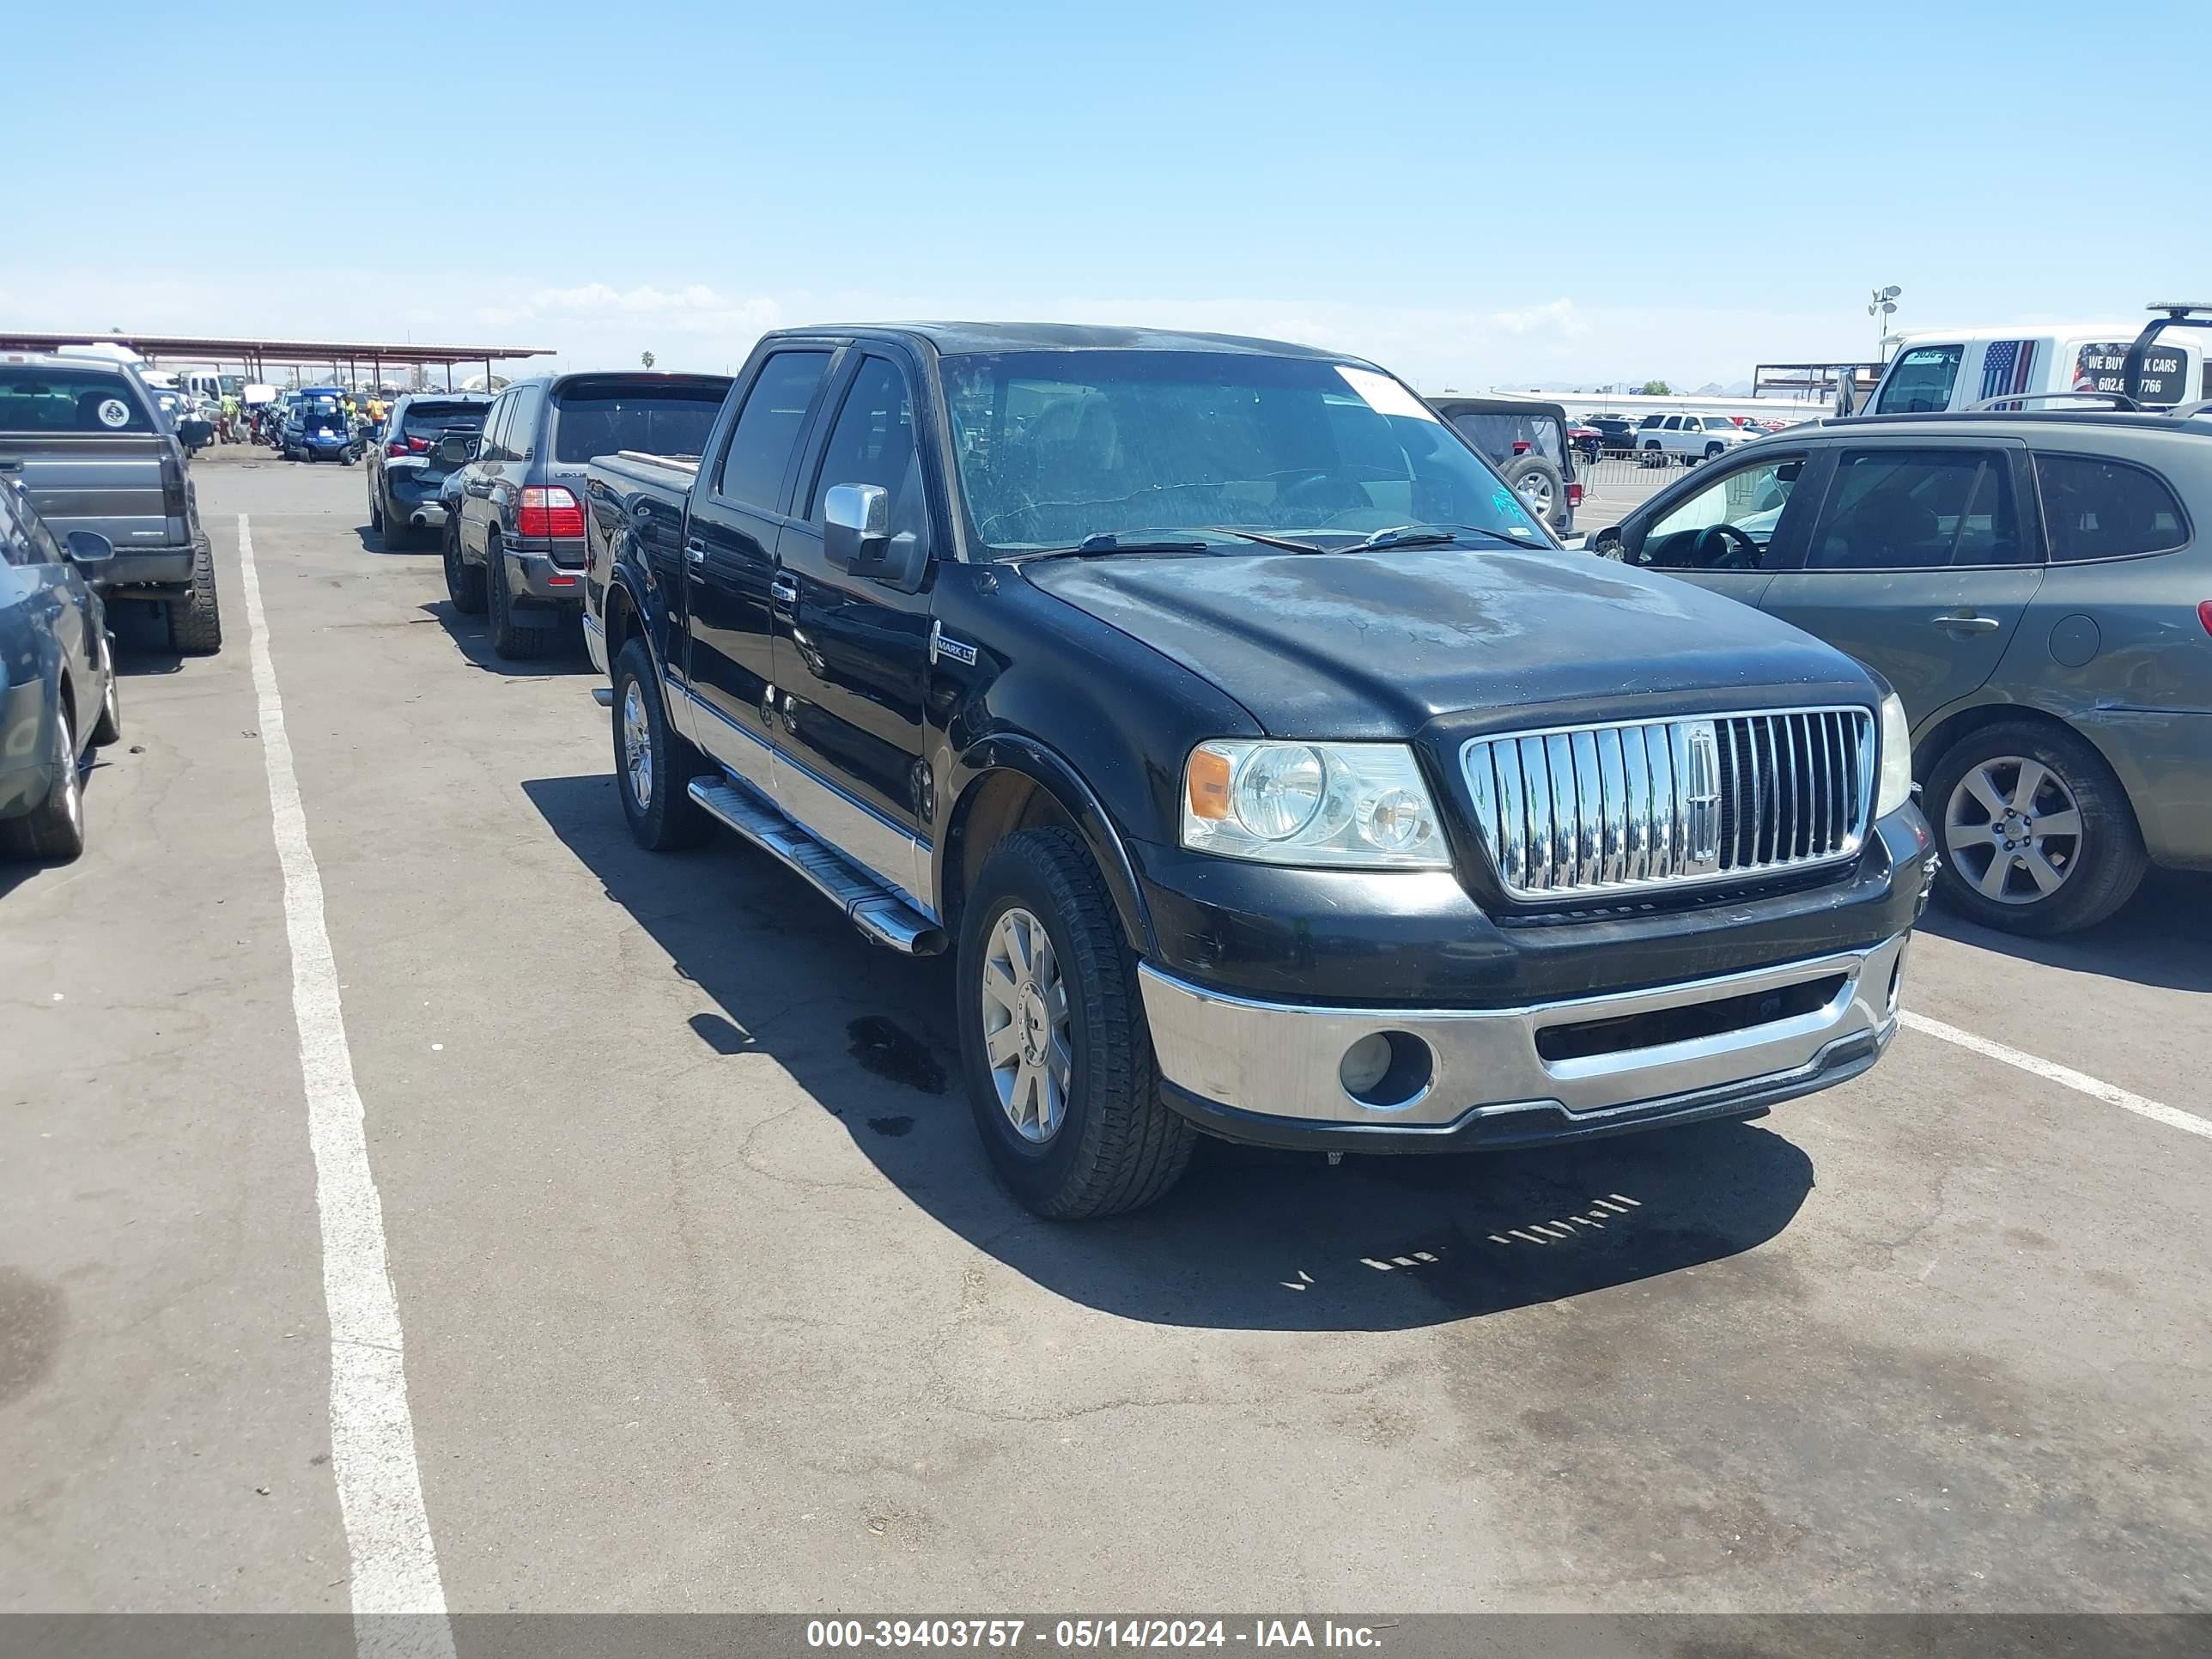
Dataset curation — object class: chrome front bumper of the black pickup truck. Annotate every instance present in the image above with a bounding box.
[1137,933,1907,1144]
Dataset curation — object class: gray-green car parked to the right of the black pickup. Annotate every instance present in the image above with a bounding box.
[1593,410,2212,933]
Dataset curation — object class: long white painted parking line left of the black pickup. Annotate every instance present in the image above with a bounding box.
[239,514,453,1659]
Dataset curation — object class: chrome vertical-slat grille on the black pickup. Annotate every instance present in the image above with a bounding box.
[1460,708,1874,898]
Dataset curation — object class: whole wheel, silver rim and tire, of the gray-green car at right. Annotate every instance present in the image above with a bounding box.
[1924,721,2150,936]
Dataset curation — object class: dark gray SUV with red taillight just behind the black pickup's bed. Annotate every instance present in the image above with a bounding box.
[445,369,730,657]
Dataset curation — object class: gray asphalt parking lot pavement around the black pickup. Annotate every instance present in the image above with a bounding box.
[0,453,2212,1613]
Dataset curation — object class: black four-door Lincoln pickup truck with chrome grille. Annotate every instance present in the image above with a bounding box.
[586,323,1931,1217]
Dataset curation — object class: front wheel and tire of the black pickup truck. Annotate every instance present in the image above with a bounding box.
[957,830,1197,1221]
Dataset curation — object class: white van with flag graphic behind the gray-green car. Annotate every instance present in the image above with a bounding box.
[1863,307,2212,414]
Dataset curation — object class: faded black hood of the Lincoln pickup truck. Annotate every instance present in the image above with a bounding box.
[1022,546,1875,738]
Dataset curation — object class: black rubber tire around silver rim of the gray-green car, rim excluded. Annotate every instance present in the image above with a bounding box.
[1923,721,2150,938]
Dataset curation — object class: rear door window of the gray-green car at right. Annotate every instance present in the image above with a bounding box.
[1805,449,2021,571]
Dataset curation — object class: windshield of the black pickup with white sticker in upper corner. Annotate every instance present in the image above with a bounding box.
[945,352,1551,553]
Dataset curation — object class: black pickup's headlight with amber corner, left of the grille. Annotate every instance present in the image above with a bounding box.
[1183,737,1451,869]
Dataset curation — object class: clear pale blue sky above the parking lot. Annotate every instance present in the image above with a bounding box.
[0,0,2212,389]
